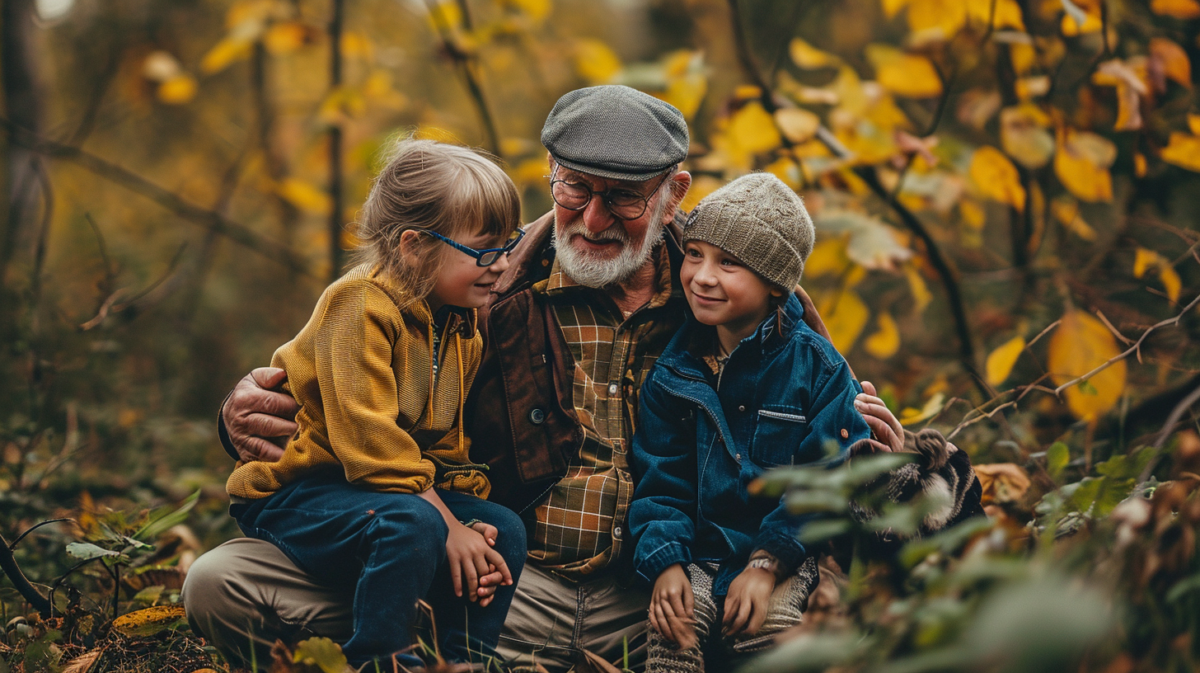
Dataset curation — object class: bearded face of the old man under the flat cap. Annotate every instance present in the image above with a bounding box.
[551,161,688,288]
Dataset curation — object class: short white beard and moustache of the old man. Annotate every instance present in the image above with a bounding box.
[553,214,664,288]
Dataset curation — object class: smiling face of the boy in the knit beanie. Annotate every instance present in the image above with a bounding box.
[679,241,782,337]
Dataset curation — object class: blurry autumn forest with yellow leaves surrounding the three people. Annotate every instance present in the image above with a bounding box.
[0,0,1200,673]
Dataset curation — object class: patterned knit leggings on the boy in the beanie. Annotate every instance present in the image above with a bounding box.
[646,558,820,673]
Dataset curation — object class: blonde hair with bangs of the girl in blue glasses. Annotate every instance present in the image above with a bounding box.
[356,137,521,301]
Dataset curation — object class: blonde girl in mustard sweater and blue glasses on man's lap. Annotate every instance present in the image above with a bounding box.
[227,140,526,669]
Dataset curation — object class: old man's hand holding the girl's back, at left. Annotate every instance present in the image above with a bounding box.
[221,367,300,463]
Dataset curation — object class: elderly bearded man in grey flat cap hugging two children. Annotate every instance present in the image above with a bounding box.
[184,86,902,671]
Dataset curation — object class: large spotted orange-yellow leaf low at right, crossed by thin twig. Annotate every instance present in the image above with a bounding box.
[1046,308,1126,420]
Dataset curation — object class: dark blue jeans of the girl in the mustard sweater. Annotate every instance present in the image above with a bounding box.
[229,475,526,669]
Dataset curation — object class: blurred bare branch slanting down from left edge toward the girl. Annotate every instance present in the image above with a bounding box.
[0,118,312,276]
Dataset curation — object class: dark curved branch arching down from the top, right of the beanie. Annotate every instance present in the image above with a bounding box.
[728,0,995,398]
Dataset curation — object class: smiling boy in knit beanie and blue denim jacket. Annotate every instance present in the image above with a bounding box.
[629,173,870,673]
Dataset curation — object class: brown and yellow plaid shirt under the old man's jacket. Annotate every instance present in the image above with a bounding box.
[526,246,684,581]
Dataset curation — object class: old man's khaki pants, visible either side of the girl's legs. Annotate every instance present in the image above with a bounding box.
[182,537,650,673]
